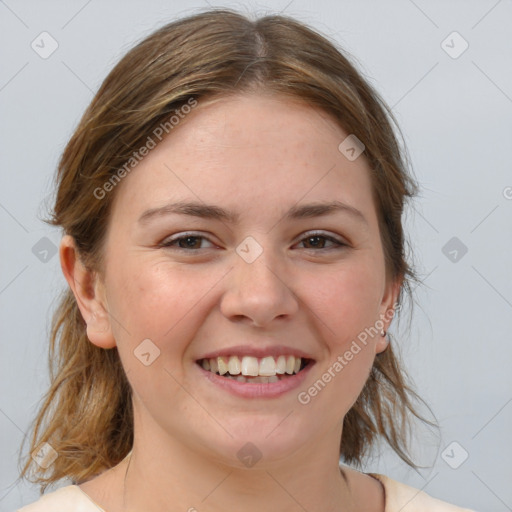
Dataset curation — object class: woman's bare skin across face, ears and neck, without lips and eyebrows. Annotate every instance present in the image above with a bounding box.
[60,93,400,512]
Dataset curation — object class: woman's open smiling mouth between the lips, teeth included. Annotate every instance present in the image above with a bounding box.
[196,354,314,384]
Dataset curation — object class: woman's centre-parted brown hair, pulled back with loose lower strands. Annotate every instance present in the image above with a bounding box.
[22,9,431,491]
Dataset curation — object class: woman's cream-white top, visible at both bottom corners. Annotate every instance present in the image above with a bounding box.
[17,473,475,512]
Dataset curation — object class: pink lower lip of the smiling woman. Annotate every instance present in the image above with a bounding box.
[196,362,314,398]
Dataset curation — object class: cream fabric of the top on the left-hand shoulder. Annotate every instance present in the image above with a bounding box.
[17,485,104,512]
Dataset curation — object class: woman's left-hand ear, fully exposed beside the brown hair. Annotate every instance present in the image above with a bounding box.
[59,235,116,349]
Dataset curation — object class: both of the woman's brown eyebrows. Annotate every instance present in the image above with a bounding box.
[138,201,368,224]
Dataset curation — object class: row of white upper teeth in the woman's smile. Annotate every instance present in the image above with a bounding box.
[201,356,302,377]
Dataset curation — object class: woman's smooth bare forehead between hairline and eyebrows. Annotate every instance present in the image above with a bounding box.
[110,94,372,228]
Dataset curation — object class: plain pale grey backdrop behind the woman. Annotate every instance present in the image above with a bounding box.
[0,0,512,511]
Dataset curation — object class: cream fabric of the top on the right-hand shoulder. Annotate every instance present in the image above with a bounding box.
[368,473,475,512]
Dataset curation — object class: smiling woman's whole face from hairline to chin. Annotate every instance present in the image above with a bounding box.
[74,94,398,465]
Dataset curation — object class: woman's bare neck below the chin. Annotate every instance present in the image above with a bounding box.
[120,422,356,512]
